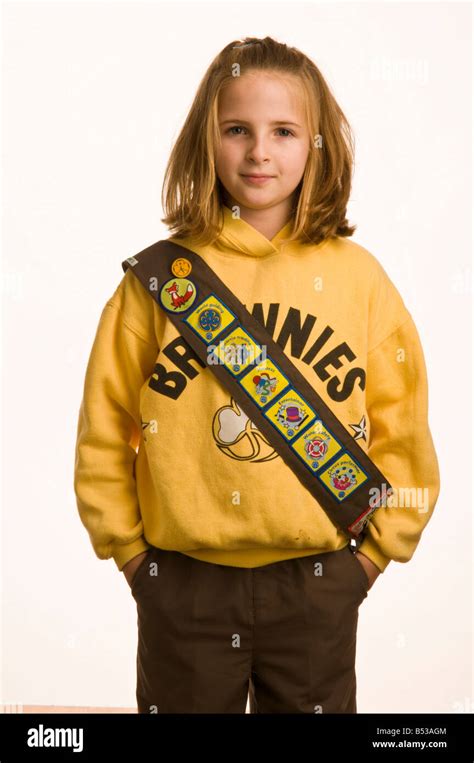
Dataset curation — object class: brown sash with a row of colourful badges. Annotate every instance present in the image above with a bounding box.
[122,240,391,545]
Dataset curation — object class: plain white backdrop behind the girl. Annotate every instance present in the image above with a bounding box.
[1,0,474,713]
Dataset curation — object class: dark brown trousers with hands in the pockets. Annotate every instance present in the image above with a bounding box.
[131,545,369,713]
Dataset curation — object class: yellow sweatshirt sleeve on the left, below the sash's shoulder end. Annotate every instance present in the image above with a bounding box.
[74,274,158,570]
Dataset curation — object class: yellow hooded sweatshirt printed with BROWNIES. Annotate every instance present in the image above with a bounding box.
[74,207,440,572]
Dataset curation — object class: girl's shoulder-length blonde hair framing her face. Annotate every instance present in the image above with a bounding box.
[162,37,356,245]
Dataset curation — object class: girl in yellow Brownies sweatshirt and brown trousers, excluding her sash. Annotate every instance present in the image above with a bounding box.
[74,37,439,713]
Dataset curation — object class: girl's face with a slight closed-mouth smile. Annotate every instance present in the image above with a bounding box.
[216,70,310,216]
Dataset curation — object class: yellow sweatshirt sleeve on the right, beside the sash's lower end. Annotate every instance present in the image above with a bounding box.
[359,311,440,572]
